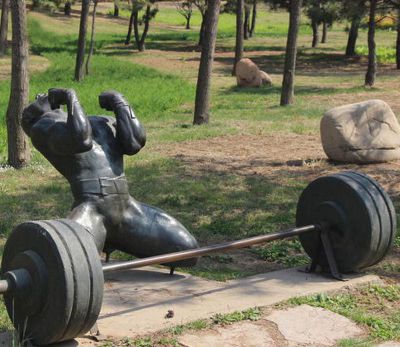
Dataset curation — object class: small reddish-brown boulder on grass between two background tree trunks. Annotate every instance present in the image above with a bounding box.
[236,58,272,88]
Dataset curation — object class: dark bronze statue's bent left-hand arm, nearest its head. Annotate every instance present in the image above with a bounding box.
[47,88,93,154]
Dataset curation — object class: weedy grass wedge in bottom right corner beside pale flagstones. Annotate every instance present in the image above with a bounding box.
[289,285,400,341]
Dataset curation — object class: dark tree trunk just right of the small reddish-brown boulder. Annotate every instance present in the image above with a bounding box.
[281,0,302,106]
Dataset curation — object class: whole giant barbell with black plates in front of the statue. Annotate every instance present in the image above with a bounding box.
[0,172,396,345]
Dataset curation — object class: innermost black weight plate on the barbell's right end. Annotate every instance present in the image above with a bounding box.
[296,174,380,273]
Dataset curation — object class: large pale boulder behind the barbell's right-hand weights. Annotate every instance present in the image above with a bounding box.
[321,100,400,164]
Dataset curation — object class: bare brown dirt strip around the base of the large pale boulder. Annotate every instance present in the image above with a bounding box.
[154,133,400,197]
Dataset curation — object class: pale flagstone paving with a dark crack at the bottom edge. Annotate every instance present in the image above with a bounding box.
[178,305,364,347]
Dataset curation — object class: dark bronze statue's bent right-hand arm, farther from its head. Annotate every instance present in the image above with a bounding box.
[99,91,146,155]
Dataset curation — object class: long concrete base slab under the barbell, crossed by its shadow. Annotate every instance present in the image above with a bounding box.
[98,268,380,337]
